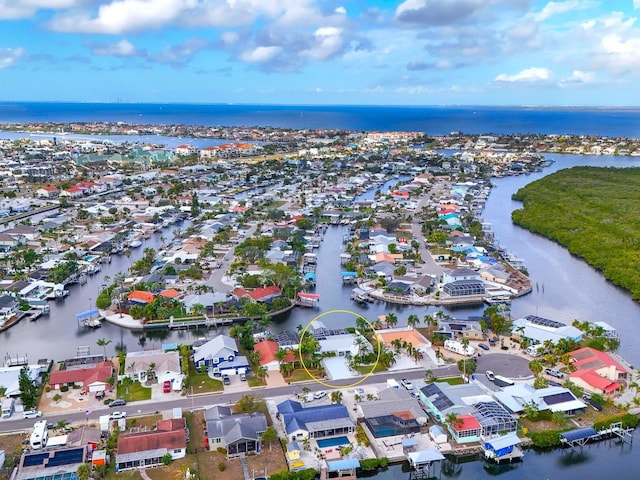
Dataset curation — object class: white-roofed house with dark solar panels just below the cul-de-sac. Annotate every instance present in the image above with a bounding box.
[493,383,586,415]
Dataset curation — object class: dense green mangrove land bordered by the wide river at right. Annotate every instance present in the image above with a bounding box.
[512,167,640,300]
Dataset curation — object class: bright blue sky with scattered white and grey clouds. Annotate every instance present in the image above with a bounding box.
[0,0,640,106]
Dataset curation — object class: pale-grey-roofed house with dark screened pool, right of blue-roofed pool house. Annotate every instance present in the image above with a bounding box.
[357,388,427,438]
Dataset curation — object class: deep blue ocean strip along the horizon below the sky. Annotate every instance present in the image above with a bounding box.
[0,102,640,137]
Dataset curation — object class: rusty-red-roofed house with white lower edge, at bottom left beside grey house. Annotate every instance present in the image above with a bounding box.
[116,418,187,472]
